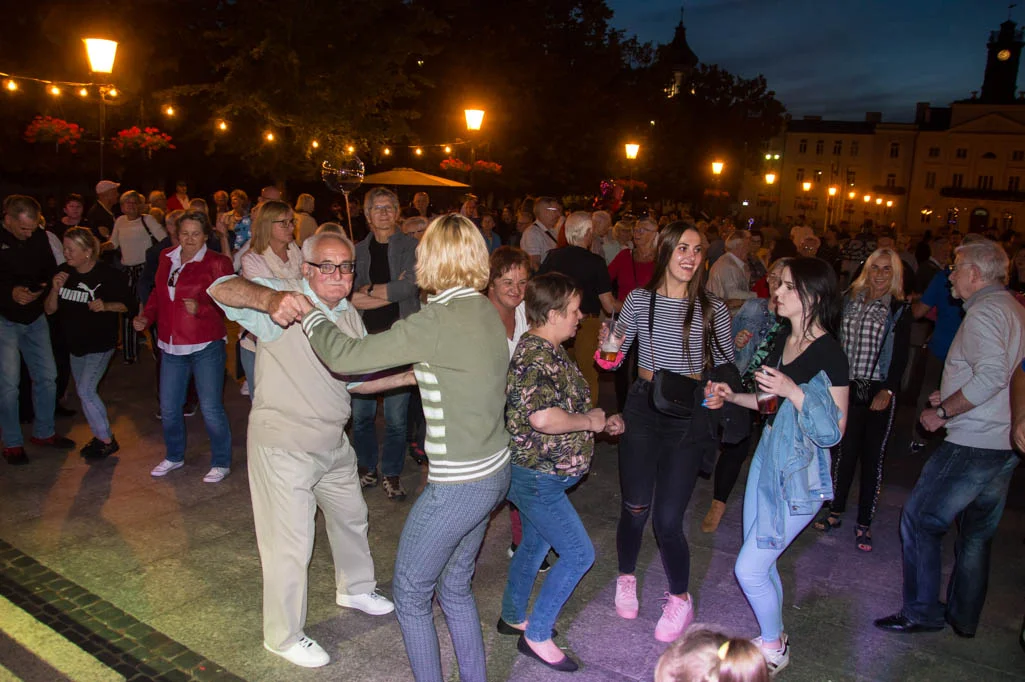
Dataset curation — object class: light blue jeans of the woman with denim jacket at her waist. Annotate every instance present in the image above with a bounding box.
[733,445,821,642]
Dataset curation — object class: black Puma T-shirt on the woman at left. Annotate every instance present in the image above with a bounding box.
[55,263,135,356]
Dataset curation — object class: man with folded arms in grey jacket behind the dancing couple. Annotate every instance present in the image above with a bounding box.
[353,187,420,502]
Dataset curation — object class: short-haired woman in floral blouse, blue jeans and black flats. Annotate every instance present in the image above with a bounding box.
[498,273,623,671]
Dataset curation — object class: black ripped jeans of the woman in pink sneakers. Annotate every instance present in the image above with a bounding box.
[616,378,701,595]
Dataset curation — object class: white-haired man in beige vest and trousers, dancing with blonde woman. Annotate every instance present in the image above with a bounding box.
[208,232,405,668]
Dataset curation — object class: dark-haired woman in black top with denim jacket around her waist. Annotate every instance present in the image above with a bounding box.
[709,257,848,674]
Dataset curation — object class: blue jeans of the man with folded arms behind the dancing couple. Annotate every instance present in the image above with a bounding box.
[350,387,409,476]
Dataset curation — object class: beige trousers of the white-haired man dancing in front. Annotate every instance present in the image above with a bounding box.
[247,442,377,651]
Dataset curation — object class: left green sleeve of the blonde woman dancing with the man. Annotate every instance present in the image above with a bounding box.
[302,307,440,374]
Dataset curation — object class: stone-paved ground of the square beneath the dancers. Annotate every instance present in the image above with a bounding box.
[0,354,1025,682]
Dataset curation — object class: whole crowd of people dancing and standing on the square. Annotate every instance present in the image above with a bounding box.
[0,180,1025,681]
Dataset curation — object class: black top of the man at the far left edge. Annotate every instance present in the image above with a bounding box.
[0,227,57,324]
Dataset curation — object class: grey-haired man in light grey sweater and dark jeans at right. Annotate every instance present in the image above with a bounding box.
[875,239,1025,637]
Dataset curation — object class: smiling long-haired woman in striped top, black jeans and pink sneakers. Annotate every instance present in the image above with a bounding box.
[603,222,733,642]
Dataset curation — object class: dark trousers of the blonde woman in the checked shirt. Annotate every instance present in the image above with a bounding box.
[829,396,897,526]
